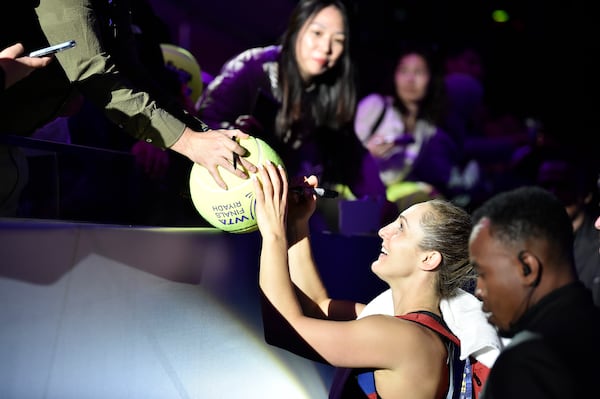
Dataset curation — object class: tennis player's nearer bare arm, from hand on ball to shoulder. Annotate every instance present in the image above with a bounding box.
[252,164,414,368]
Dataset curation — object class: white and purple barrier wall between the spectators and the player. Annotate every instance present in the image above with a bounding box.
[0,219,383,399]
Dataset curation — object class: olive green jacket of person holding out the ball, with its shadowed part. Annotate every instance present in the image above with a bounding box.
[0,0,195,147]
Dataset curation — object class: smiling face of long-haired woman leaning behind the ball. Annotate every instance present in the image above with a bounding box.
[296,6,346,82]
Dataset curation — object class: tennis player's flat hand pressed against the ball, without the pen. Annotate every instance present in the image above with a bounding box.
[251,161,288,240]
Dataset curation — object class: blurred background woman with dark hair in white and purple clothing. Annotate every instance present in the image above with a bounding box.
[354,44,477,210]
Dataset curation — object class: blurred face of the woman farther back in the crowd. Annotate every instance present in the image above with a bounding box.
[394,54,431,103]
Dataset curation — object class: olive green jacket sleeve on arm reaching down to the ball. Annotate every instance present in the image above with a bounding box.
[36,0,185,147]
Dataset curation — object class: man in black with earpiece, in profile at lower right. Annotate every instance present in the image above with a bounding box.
[469,186,600,399]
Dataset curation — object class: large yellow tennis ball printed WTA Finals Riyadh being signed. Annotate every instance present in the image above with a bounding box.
[190,137,283,233]
